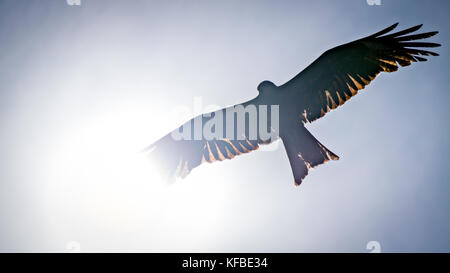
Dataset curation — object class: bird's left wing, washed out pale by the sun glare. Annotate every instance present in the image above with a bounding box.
[147,106,270,180]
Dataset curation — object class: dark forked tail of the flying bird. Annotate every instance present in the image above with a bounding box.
[282,126,339,186]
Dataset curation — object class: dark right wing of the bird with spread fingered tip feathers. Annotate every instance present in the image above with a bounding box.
[280,23,440,122]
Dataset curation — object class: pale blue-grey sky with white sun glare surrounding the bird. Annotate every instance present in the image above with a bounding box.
[0,0,450,252]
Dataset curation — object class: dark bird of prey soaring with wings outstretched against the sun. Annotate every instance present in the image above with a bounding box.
[147,23,440,186]
